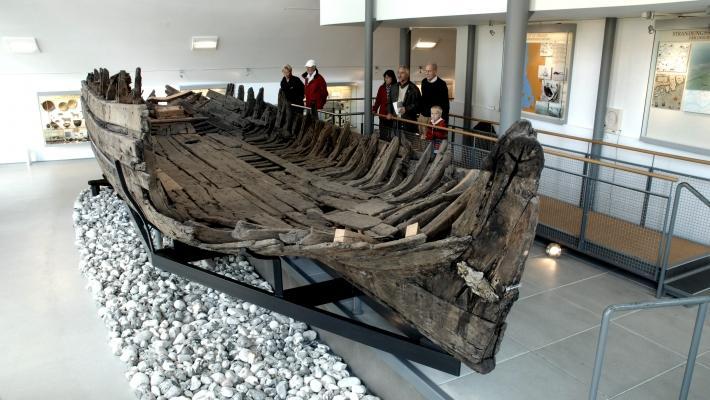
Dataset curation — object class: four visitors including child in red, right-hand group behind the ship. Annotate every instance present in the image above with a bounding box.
[372,63,449,140]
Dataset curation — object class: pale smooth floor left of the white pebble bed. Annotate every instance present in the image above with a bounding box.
[0,160,135,400]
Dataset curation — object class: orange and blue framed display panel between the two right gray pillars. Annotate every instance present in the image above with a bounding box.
[521,25,576,124]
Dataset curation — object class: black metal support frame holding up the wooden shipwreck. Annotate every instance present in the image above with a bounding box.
[105,161,461,375]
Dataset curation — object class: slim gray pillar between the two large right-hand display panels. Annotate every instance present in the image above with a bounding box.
[579,18,616,247]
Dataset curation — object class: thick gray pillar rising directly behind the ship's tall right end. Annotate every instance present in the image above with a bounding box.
[498,0,530,136]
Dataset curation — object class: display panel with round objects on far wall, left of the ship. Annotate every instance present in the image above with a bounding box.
[37,92,89,144]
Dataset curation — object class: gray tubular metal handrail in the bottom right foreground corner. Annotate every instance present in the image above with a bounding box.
[589,296,710,400]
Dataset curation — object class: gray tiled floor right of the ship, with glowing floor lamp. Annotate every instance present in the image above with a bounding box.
[419,243,710,400]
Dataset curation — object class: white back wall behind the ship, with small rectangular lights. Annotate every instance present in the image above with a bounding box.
[0,0,399,163]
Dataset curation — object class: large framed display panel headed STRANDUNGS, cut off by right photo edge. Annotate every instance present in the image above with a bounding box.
[641,19,710,154]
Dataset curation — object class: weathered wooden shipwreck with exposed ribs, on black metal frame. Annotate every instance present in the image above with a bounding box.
[82,69,544,373]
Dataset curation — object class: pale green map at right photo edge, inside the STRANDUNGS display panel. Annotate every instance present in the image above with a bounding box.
[683,41,710,114]
